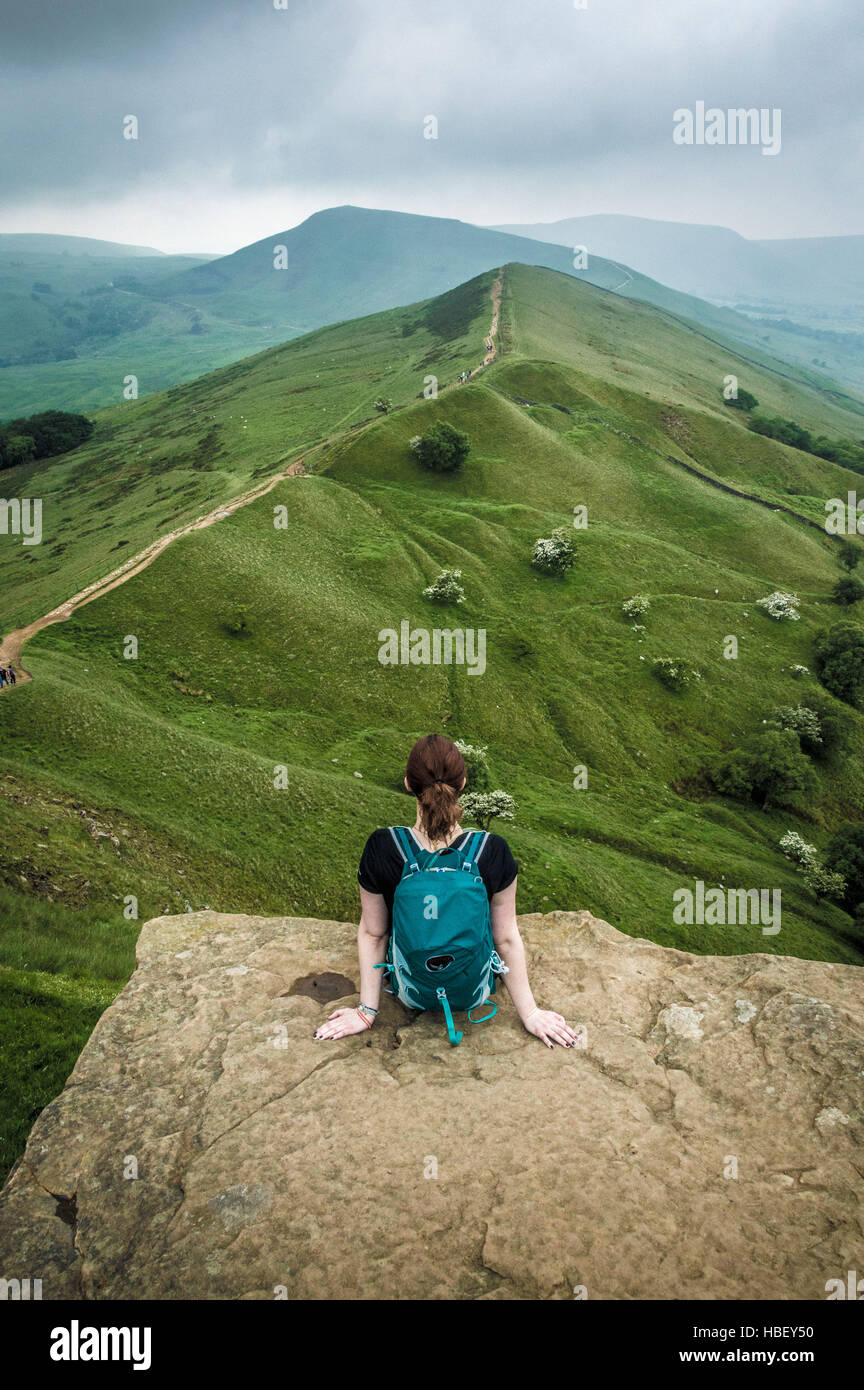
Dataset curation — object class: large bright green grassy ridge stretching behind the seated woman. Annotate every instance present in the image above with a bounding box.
[0,265,864,1173]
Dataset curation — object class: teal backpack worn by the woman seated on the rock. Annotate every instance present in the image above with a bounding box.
[375,826,507,1047]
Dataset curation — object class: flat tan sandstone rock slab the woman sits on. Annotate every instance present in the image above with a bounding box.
[0,912,864,1300]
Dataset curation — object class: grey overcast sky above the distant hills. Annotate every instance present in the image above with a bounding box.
[0,0,864,253]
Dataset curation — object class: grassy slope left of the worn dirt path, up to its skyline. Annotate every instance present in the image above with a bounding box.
[0,274,493,628]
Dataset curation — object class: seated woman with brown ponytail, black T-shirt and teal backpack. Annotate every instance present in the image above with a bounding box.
[313,734,576,1047]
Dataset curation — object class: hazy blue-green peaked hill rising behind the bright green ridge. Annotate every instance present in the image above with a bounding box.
[0,207,860,418]
